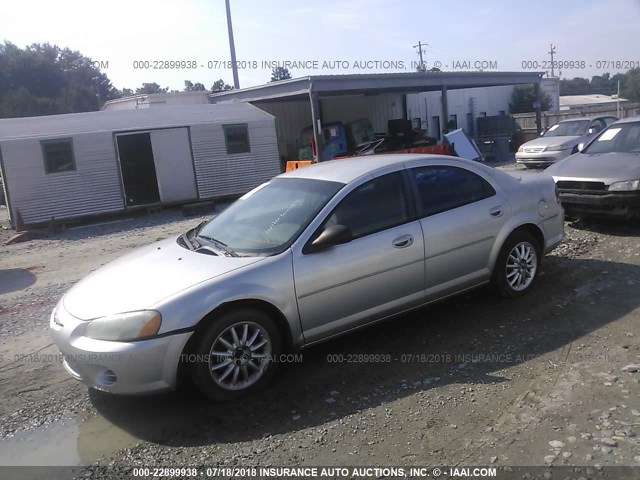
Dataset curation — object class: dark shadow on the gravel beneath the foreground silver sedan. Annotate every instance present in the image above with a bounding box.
[87,257,640,446]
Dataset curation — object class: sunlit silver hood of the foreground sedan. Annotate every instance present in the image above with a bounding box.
[63,237,264,320]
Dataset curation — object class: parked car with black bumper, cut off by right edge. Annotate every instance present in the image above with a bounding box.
[545,117,640,219]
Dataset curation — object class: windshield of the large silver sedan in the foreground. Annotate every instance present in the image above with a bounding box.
[196,178,344,255]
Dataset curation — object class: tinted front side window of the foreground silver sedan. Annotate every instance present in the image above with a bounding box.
[319,172,409,238]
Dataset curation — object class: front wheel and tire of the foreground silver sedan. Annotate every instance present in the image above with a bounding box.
[190,308,282,401]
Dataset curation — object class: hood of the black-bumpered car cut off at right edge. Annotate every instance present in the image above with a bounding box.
[545,153,640,185]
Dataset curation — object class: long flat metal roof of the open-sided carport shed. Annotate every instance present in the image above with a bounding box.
[210,72,543,103]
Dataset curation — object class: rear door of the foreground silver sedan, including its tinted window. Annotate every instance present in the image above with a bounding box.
[409,164,511,300]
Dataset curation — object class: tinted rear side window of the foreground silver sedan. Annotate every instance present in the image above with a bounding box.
[410,166,496,217]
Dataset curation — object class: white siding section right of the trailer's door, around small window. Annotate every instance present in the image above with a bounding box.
[191,119,280,199]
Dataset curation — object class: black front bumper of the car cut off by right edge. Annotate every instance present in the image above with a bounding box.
[560,190,640,218]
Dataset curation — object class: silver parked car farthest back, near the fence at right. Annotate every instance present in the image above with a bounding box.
[516,115,618,167]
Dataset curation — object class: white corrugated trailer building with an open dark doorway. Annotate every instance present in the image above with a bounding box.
[0,103,280,226]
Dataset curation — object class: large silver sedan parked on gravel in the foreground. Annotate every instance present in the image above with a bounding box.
[50,155,564,400]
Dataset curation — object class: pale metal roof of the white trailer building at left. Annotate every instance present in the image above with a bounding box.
[0,103,273,141]
